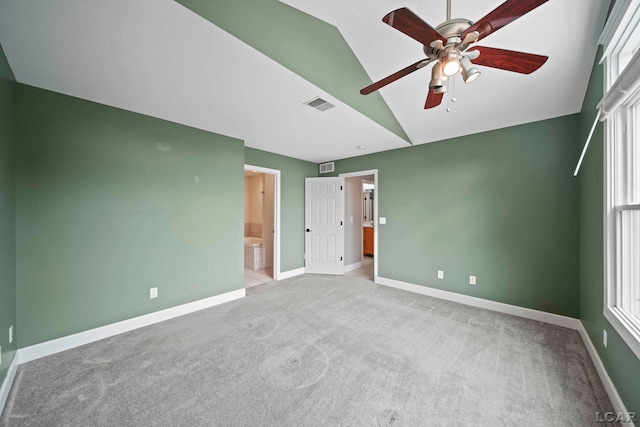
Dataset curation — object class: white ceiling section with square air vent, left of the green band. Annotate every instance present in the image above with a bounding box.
[0,0,408,162]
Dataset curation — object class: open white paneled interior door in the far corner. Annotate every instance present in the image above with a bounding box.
[304,178,344,274]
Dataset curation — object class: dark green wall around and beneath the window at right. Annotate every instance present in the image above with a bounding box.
[580,51,640,414]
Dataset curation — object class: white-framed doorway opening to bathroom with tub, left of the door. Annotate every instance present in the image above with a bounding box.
[244,165,280,288]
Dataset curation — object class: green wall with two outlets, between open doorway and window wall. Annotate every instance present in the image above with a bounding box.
[336,115,579,317]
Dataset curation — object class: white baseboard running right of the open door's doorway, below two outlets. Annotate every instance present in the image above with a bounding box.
[376,277,582,330]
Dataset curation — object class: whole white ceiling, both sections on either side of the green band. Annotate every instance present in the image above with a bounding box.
[0,0,609,162]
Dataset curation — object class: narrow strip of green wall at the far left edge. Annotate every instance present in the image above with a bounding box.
[0,46,18,385]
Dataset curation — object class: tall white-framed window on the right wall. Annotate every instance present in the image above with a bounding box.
[600,0,640,357]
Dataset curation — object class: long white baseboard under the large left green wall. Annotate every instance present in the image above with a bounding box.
[17,288,246,364]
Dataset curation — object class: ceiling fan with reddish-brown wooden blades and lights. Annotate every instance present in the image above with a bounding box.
[360,0,548,109]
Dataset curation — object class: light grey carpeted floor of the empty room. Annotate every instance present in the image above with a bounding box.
[0,275,613,427]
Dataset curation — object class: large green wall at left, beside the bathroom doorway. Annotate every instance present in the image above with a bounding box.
[16,86,244,347]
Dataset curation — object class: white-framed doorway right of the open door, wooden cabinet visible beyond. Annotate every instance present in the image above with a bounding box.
[339,169,378,282]
